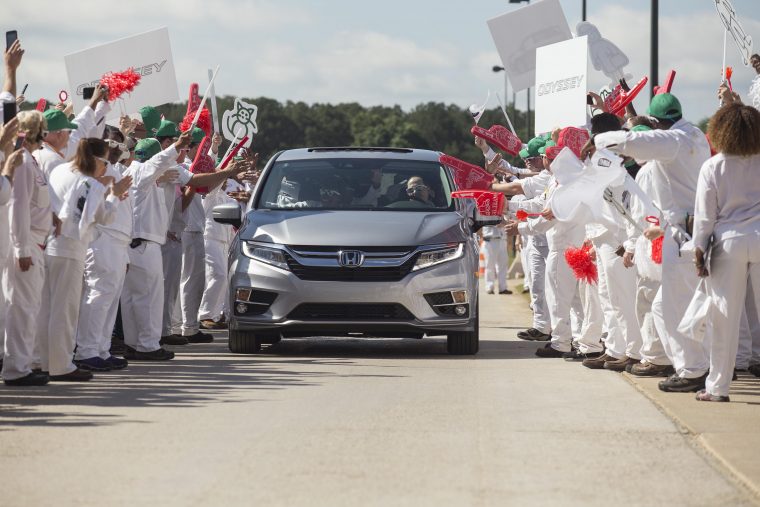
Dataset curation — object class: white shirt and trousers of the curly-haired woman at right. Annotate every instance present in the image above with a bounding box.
[692,154,760,396]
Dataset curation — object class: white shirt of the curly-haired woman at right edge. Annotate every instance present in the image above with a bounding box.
[694,153,760,251]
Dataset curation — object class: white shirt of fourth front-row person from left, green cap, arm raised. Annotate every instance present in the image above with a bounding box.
[124,144,192,245]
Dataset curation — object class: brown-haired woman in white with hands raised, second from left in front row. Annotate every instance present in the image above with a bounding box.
[37,138,132,382]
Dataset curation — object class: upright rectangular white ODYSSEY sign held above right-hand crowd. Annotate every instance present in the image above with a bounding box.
[536,37,588,134]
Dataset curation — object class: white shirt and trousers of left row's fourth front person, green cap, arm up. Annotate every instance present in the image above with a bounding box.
[121,145,192,352]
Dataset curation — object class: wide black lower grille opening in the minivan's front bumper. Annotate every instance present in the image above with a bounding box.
[288,303,414,320]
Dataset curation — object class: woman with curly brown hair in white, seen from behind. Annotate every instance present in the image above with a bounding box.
[694,103,760,401]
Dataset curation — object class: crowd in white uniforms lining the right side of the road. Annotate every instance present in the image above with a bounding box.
[475,55,760,401]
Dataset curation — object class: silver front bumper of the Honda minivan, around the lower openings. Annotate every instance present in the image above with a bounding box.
[230,250,478,337]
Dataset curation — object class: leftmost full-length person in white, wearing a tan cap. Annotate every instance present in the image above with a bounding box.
[3,111,53,386]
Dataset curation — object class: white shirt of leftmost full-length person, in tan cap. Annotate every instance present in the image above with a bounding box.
[9,149,53,258]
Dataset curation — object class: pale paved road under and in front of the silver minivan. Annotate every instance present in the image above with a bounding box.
[0,295,754,506]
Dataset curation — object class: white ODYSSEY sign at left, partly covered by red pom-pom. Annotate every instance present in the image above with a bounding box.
[64,28,179,118]
